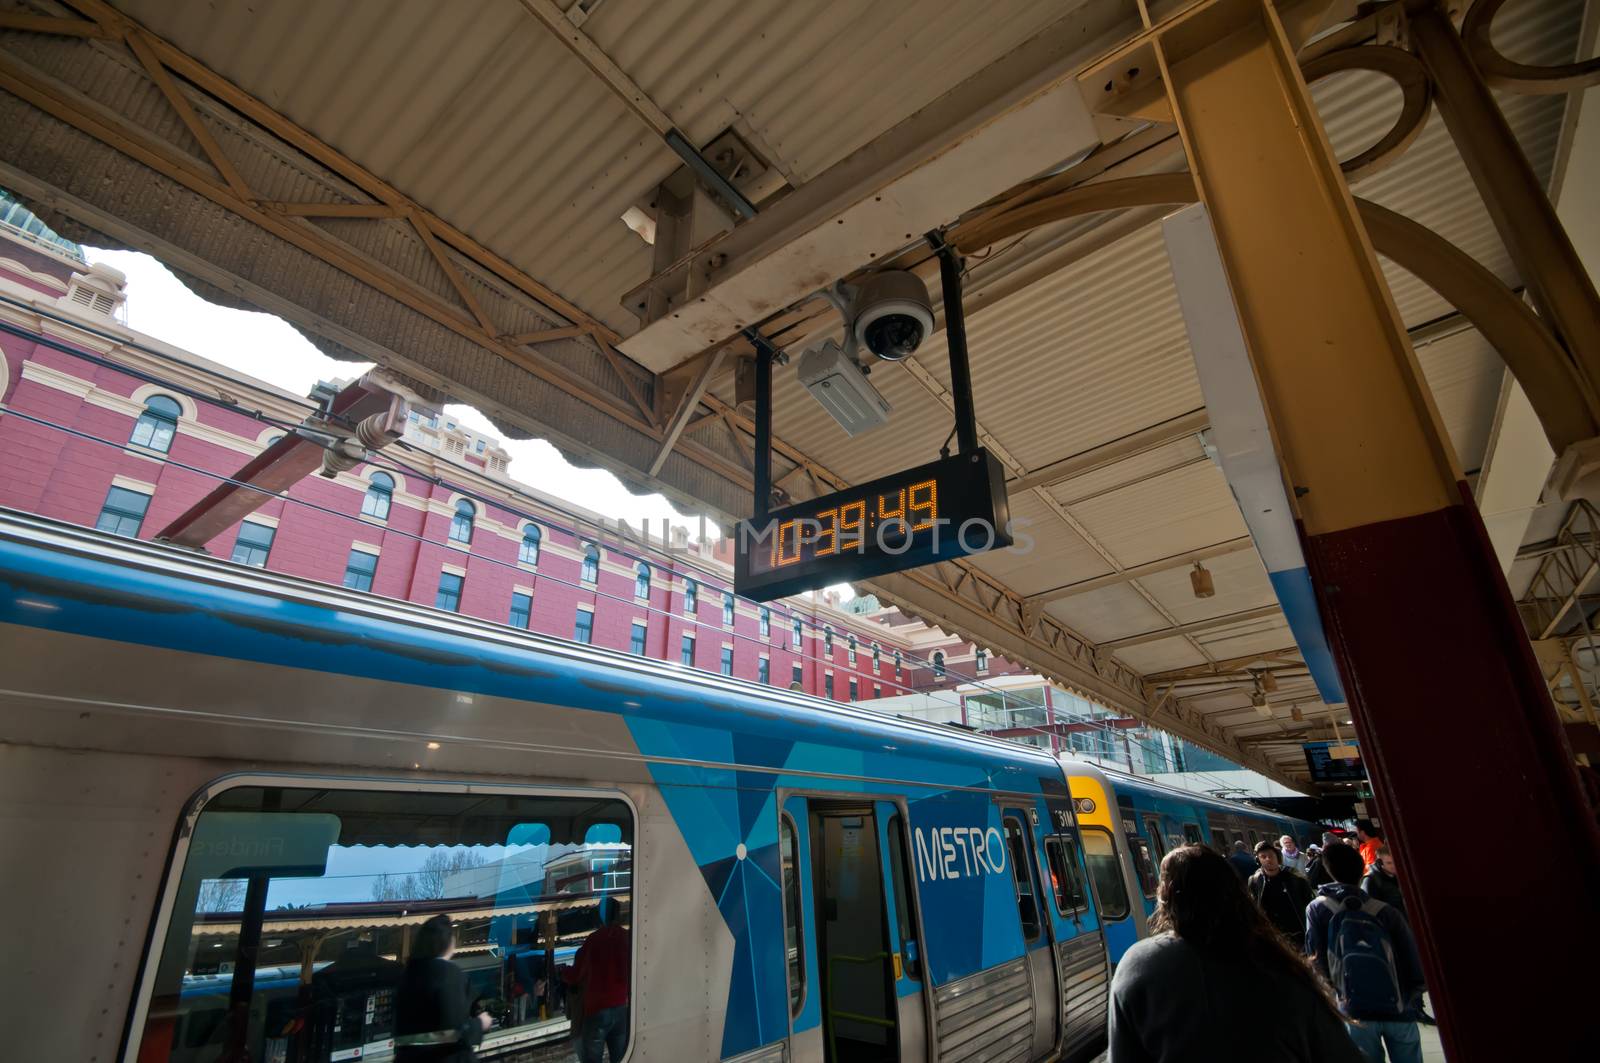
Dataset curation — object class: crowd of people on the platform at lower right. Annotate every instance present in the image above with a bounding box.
[1109,823,1434,1063]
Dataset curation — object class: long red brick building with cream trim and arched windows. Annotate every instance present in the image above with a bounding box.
[0,211,1018,701]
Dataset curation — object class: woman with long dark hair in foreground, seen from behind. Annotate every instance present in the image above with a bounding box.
[1110,845,1363,1063]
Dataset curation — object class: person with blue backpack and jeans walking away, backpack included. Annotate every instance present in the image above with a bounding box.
[1306,845,1427,1063]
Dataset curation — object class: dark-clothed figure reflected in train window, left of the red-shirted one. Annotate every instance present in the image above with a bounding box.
[395,916,491,1063]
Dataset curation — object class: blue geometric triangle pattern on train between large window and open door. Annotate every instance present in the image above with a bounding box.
[629,717,794,1058]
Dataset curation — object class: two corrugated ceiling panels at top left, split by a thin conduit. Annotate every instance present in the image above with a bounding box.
[117,0,1080,331]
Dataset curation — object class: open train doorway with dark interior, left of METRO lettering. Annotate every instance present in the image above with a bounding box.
[810,800,909,1063]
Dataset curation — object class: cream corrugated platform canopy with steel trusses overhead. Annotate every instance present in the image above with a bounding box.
[0,0,1592,786]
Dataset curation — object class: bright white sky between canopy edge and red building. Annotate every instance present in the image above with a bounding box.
[83,248,732,541]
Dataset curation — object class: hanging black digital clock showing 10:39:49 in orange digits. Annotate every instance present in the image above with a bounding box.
[734,450,1011,602]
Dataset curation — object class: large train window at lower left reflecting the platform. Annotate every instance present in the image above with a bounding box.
[138,780,634,1063]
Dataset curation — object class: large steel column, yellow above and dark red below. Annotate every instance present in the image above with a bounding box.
[1145,0,1600,1061]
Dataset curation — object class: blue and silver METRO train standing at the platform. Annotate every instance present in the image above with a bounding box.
[0,511,1310,1063]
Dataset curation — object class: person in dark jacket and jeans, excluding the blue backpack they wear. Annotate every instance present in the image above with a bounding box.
[1306,845,1427,1063]
